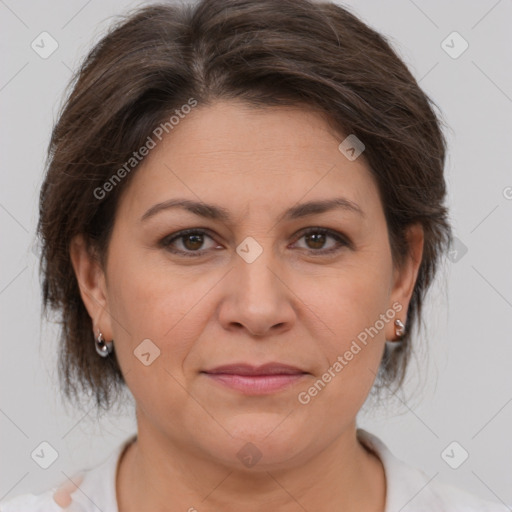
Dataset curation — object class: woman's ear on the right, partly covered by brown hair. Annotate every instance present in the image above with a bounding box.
[386,224,425,340]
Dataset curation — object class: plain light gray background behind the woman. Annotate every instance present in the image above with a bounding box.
[0,0,512,506]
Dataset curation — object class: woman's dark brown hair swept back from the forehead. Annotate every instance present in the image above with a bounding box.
[38,0,451,409]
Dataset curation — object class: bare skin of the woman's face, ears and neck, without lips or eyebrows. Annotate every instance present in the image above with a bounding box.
[71,101,423,512]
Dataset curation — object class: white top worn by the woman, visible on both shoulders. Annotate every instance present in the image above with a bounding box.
[0,428,504,512]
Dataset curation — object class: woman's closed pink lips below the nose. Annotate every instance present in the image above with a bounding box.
[202,363,307,395]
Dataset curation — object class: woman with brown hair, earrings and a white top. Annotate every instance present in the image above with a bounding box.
[2,0,505,512]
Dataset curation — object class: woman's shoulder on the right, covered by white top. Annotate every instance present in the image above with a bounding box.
[357,429,510,512]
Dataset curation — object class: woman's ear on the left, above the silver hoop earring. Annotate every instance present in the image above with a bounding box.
[69,235,113,341]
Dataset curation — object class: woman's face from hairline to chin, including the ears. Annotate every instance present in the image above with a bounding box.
[76,102,422,467]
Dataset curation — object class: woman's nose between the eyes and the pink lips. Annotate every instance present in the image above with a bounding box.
[219,245,296,337]
